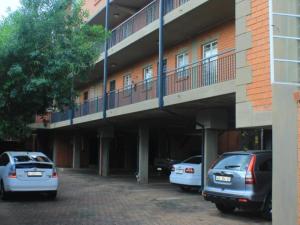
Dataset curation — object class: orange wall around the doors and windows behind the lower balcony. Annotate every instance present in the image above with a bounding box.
[80,21,235,102]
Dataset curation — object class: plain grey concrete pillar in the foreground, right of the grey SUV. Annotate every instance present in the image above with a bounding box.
[272,84,299,225]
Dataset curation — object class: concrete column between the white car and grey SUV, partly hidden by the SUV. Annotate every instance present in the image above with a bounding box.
[204,129,218,186]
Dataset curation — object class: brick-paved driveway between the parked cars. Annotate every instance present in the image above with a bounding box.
[0,170,271,225]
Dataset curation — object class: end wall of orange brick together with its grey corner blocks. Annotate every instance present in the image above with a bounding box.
[236,0,272,127]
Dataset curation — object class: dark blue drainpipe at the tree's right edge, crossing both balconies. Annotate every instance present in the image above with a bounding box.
[102,0,110,119]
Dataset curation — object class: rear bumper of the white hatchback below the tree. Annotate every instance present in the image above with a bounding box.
[6,178,58,192]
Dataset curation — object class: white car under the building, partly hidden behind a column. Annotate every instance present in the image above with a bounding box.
[170,155,202,190]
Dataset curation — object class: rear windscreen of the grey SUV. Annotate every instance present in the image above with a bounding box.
[213,155,251,171]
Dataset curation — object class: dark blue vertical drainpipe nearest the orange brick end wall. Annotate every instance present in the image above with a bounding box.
[158,0,164,109]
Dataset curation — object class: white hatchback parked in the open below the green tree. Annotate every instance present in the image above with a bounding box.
[0,152,58,199]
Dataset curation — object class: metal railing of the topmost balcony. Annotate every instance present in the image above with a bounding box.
[108,0,190,48]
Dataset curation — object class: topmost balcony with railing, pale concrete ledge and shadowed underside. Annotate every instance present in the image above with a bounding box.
[85,0,235,81]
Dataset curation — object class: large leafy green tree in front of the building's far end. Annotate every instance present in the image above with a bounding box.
[0,0,106,139]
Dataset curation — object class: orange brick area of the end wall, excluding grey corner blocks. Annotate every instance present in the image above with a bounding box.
[247,0,272,111]
